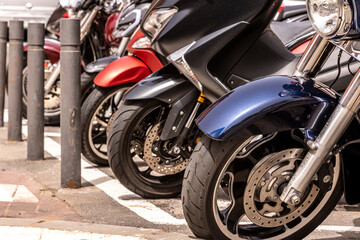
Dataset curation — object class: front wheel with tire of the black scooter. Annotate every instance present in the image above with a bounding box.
[108,101,200,198]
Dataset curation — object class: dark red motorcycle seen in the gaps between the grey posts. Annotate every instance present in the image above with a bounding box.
[22,0,124,125]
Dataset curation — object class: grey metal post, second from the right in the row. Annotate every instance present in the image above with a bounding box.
[27,23,45,160]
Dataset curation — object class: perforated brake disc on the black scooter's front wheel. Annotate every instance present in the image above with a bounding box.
[144,122,189,175]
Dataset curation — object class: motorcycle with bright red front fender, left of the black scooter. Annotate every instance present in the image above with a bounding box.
[81,0,166,165]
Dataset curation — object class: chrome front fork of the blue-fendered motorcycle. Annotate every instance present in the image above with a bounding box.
[280,35,360,205]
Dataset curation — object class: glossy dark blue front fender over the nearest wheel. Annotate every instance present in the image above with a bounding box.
[197,76,338,141]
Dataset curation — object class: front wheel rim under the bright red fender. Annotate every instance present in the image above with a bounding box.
[88,87,129,161]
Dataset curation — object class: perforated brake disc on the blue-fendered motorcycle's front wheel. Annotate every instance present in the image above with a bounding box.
[244,148,319,227]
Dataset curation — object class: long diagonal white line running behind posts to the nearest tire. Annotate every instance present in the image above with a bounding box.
[22,126,186,225]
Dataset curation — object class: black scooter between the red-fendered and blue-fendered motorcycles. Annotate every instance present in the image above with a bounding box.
[107,0,356,198]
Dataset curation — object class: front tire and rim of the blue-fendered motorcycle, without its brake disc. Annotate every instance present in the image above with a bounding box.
[182,134,343,240]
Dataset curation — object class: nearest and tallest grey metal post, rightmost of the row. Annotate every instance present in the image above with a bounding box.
[60,19,81,188]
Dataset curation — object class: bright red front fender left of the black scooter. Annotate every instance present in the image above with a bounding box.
[94,56,151,87]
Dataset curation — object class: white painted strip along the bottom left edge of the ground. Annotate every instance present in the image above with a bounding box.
[0,226,141,240]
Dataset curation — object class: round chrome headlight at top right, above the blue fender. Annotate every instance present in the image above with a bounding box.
[306,0,352,38]
